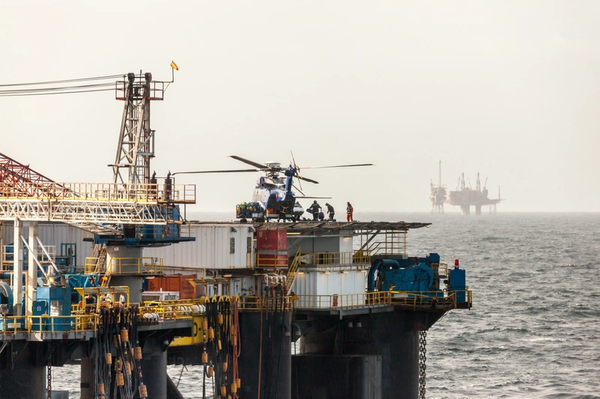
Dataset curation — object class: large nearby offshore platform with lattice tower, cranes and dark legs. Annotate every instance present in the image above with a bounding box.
[0,72,472,399]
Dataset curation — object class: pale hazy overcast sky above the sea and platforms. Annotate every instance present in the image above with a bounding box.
[0,0,600,213]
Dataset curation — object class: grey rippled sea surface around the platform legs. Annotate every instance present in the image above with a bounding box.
[53,214,600,399]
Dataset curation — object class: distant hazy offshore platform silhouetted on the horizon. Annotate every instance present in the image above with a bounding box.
[430,161,502,215]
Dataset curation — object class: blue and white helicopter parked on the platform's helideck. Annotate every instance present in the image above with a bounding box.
[173,154,373,222]
